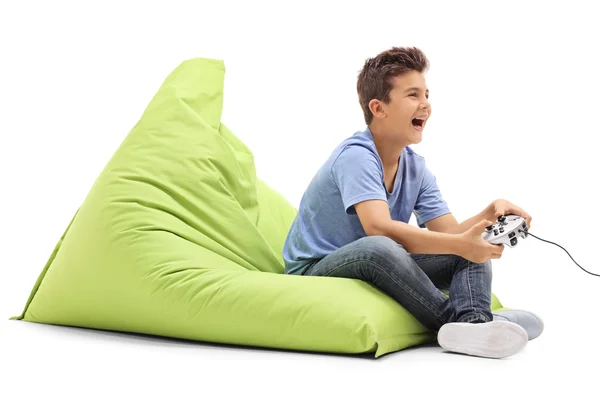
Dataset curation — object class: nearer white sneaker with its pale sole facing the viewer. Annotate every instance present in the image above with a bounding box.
[437,321,529,358]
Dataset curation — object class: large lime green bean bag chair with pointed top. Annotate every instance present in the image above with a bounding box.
[12,58,501,357]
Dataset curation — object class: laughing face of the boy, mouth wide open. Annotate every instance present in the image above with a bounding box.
[370,71,431,145]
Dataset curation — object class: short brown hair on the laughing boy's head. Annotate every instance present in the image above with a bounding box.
[356,47,429,125]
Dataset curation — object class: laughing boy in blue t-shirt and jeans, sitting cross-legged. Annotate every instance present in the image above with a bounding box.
[283,47,542,358]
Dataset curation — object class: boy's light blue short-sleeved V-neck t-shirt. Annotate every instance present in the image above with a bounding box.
[283,127,450,275]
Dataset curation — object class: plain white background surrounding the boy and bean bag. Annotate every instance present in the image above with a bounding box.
[0,0,600,399]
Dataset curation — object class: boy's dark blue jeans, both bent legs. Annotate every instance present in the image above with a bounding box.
[303,236,493,331]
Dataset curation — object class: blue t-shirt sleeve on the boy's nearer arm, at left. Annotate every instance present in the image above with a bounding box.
[331,145,387,214]
